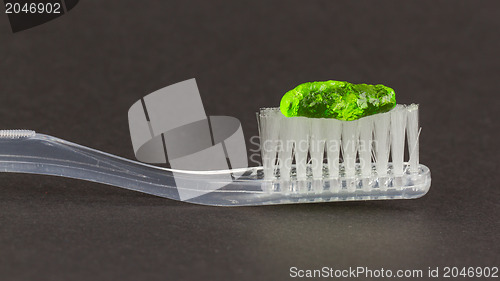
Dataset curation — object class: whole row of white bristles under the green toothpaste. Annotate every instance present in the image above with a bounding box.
[257,104,419,187]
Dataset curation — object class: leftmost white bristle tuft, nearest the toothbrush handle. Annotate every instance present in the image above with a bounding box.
[257,108,283,179]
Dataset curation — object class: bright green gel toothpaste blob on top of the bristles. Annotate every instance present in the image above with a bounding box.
[280,80,396,121]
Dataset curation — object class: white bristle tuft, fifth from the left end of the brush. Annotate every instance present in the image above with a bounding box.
[325,119,343,179]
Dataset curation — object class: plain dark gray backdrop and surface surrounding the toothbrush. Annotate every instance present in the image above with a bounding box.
[0,0,500,280]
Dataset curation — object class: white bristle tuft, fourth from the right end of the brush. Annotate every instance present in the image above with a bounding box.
[358,116,373,177]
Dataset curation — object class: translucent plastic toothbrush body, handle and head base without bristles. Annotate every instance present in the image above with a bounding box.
[0,131,431,206]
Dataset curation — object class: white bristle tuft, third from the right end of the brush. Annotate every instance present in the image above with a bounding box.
[373,112,391,176]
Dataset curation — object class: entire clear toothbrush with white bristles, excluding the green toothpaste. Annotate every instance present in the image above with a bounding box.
[0,84,431,206]
